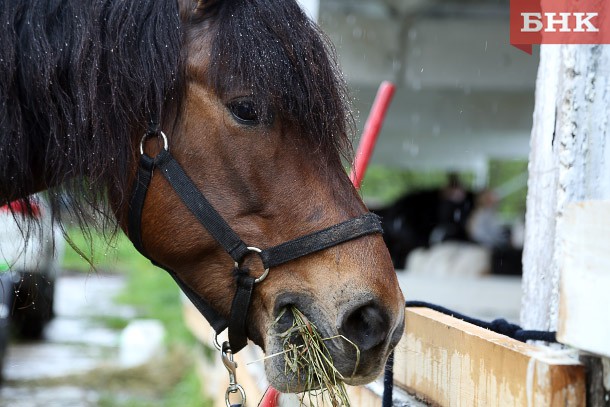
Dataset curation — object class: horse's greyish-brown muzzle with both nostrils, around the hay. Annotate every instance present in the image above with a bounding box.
[265,293,404,392]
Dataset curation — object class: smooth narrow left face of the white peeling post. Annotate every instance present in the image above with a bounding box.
[521,45,560,330]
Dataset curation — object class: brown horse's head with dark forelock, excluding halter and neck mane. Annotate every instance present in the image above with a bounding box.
[119,1,404,391]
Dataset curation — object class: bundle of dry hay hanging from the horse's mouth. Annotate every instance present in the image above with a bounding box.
[269,306,360,406]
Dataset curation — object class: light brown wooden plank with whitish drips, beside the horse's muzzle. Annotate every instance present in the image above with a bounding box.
[394,308,585,407]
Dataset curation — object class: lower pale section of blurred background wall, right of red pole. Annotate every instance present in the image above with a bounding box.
[355,87,533,169]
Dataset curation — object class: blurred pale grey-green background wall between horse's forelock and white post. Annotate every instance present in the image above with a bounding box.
[320,8,538,171]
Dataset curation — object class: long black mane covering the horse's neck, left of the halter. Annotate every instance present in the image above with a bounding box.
[0,0,182,226]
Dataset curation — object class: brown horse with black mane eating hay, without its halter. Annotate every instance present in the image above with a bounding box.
[0,0,404,391]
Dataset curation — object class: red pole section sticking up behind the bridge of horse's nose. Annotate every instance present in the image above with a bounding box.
[349,81,396,189]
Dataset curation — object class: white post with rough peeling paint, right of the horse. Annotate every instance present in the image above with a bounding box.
[521,45,610,398]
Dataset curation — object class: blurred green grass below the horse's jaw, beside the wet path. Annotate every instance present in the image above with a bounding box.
[63,228,211,407]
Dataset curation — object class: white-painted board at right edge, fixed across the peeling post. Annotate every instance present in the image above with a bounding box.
[557,201,610,357]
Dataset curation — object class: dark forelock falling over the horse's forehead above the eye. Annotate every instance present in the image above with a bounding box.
[201,0,354,164]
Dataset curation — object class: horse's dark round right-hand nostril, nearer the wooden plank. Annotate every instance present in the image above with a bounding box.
[339,303,390,351]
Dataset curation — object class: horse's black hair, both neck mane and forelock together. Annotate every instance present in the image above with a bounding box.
[0,0,352,230]
